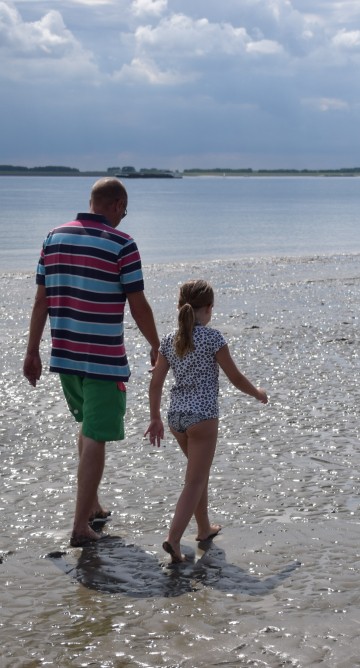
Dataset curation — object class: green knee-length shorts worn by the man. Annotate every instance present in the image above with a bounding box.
[60,373,126,442]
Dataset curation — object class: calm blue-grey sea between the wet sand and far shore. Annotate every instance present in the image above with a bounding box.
[0,176,360,271]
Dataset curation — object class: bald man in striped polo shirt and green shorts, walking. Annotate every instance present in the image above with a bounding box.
[24,178,159,547]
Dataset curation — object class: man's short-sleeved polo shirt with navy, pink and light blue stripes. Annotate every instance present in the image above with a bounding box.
[36,213,144,381]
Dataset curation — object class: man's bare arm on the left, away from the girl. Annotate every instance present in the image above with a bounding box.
[23,285,48,387]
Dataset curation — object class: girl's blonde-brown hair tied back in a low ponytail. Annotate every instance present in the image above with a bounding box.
[174,280,214,357]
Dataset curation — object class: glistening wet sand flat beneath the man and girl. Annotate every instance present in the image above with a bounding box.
[0,255,360,668]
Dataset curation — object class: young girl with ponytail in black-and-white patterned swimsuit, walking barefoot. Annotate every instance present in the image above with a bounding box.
[145,280,268,563]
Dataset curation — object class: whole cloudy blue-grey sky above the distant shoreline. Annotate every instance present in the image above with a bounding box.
[0,0,360,170]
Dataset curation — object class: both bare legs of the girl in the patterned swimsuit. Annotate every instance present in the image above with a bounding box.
[168,419,218,559]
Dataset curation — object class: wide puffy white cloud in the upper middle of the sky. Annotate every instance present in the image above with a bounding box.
[109,14,283,87]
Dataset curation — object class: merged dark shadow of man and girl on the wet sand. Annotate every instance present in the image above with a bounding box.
[47,536,300,598]
